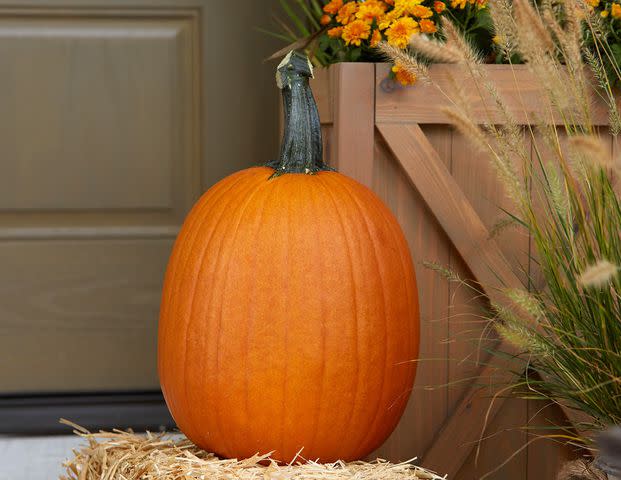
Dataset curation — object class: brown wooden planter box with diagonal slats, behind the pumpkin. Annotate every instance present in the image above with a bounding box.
[312,63,612,480]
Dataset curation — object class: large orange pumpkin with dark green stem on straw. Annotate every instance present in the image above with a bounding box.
[158,52,419,462]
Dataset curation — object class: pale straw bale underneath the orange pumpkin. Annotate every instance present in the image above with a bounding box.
[60,420,444,480]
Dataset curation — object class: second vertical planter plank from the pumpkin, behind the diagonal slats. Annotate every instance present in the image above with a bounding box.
[449,131,529,480]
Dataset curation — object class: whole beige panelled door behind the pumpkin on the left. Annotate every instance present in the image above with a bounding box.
[0,0,277,394]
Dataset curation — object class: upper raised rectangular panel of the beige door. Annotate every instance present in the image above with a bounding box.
[0,17,199,212]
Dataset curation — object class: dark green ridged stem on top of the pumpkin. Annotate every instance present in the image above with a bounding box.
[268,50,331,177]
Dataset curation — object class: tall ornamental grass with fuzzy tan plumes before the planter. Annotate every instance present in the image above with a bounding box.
[379,0,621,456]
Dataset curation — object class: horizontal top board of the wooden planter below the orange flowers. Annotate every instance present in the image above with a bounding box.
[376,64,608,125]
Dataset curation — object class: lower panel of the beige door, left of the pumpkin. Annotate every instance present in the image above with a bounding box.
[0,238,172,392]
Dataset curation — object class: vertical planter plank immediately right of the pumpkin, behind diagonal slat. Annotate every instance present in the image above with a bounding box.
[372,126,451,460]
